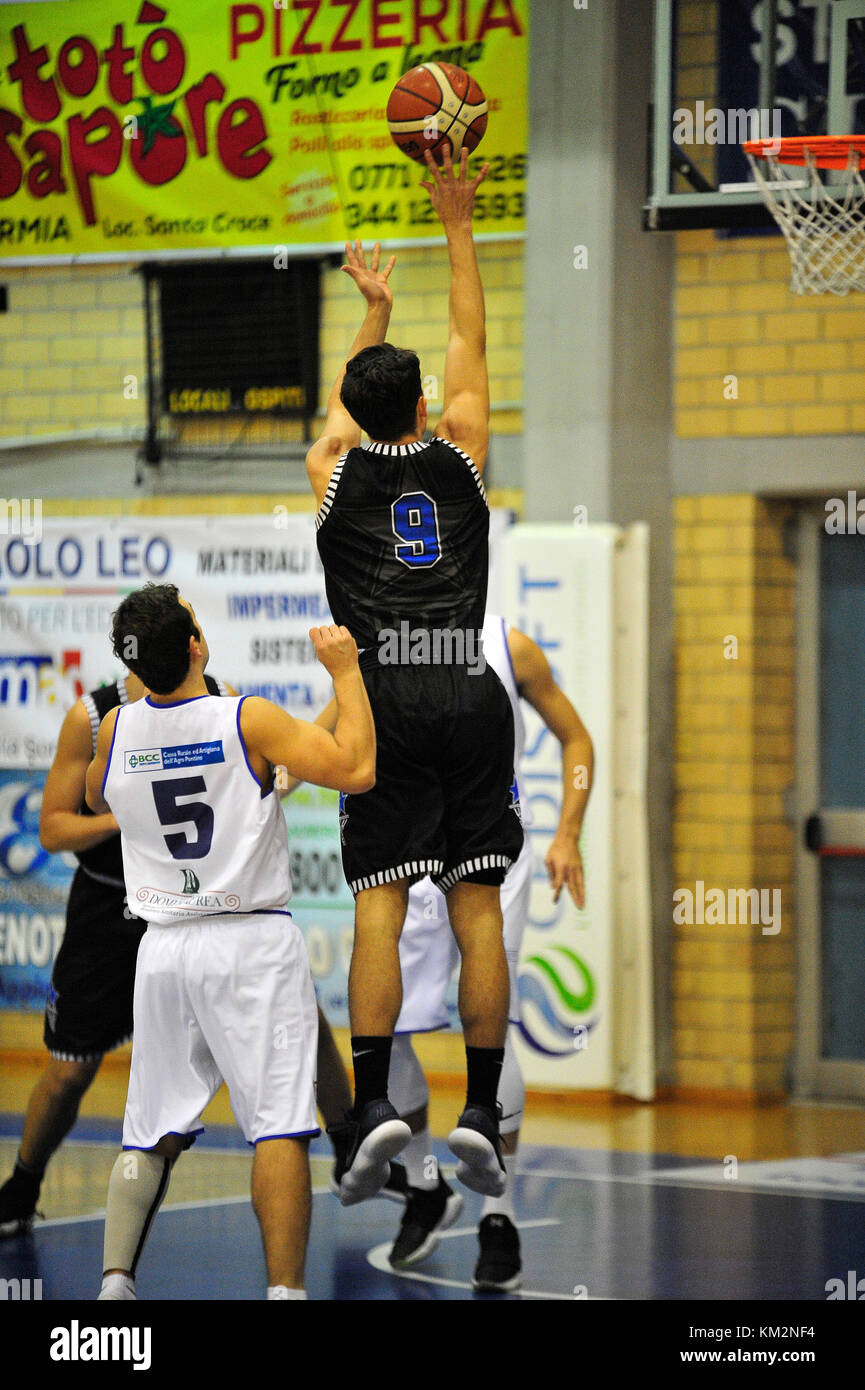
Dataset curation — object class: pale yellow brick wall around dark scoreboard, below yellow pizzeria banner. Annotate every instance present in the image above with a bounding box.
[0,242,523,443]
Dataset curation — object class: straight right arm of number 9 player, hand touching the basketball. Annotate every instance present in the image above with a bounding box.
[423,147,490,471]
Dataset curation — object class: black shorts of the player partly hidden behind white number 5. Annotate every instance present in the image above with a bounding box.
[45,869,147,1062]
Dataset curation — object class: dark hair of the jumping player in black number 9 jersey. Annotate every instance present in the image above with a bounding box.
[339,343,423,443]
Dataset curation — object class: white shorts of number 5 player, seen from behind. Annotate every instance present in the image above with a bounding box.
[122,913,318,1148]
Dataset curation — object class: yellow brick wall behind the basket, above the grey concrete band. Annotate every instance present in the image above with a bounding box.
[673,0,865,438]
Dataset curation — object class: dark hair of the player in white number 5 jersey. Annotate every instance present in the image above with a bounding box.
[111,584,202,695]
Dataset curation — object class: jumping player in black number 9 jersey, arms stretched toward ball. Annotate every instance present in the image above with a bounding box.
[307,152,523,1204]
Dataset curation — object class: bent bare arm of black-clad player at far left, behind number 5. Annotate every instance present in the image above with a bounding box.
[39,701,120,855]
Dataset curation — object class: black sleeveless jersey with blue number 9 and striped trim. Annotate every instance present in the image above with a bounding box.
[316,438,490,648]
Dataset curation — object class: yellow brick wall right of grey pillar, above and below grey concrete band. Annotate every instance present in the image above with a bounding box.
[670,0,865,1095]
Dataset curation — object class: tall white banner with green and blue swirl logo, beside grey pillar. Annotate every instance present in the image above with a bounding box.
[499,525,651,1094]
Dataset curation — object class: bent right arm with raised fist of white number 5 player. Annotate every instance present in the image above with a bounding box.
[241,627,375,792]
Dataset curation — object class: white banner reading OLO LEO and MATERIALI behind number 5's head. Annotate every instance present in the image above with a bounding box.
[0,510,330,767]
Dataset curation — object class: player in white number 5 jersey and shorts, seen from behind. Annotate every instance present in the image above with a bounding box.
[86,584,378,1300]
